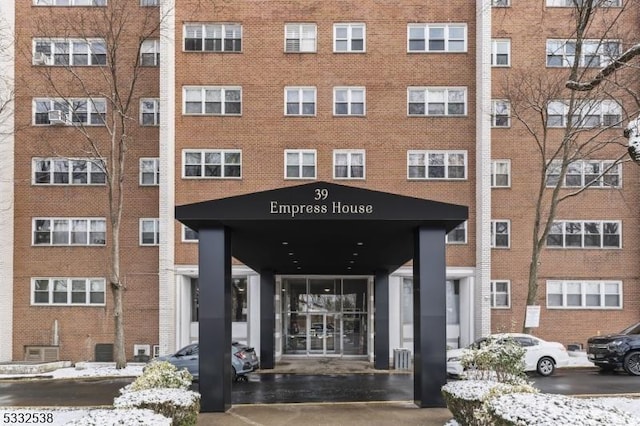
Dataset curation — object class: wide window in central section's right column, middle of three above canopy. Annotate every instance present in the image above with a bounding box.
[407,87,467,116]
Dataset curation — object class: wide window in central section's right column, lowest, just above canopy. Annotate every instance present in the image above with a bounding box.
[407,151,467,180]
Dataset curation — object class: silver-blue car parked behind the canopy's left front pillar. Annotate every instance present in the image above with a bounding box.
[156,342,260,381]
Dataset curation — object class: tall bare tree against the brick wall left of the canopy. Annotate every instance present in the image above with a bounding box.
[25,0,162,368]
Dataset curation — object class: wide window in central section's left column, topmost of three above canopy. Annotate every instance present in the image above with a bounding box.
[184,23,242,52]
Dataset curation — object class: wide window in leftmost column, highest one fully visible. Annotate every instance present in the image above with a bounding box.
[33,38,107,67]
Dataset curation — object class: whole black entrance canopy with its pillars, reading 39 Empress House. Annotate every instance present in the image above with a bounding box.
[176,182,468,412]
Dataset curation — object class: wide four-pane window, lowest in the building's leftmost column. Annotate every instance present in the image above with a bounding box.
[31,278,106,305]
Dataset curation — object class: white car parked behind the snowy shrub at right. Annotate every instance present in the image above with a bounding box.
[447,333,569,376]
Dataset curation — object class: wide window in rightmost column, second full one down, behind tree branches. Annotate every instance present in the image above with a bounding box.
[547,99,622,128]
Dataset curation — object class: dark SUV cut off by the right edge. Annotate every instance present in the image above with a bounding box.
[587,323,640,376]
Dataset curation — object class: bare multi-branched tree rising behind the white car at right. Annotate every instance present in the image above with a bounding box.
[500,0,640,332]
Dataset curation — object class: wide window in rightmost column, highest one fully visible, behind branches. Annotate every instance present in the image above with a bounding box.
[547,39,621,68]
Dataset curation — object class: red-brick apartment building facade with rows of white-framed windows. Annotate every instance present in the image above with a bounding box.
[0,0,640,372]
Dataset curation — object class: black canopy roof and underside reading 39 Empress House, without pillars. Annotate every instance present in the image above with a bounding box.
[176,182,468,275]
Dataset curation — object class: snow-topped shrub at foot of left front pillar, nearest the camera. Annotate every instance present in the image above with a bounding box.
[113,388,200,426]
